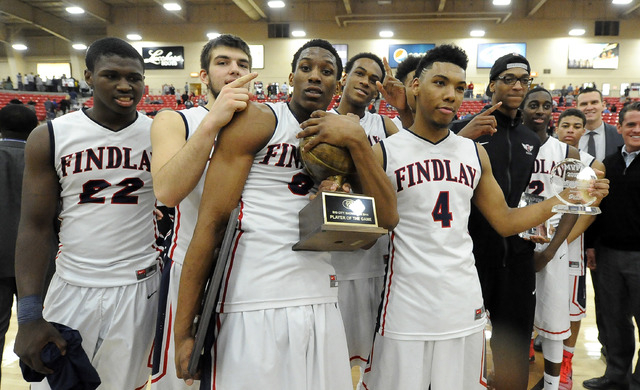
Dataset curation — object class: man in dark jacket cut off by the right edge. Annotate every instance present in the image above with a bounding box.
[583,102,640,390]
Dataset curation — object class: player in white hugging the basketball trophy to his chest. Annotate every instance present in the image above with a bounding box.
[175,39,397,390]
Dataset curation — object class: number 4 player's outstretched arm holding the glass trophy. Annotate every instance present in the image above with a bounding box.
[473,145,609,237]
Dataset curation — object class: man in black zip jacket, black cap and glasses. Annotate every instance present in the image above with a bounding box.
[451,54,540,390]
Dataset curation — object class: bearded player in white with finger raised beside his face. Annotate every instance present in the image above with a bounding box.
[151,34,257,390]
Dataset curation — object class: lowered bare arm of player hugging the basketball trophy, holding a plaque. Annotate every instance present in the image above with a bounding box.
[174,104,275,383]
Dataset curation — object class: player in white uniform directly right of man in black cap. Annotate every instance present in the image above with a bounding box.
[522,87,580,390]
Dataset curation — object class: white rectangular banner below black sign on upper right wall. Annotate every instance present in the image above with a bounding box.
[567,43,620,69]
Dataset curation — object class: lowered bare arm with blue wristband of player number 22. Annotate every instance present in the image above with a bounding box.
[14,125,66,374]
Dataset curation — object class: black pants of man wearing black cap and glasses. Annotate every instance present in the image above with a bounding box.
[476,255,536,390]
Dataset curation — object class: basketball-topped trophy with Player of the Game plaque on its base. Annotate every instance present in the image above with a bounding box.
[293,138,387,251]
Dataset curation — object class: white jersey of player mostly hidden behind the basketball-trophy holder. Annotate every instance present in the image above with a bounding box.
[331,109,389,280]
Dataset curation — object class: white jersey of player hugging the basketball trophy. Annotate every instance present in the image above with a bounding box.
[218,103,338,313]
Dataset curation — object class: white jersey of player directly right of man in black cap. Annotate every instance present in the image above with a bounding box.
[526,137,569,227]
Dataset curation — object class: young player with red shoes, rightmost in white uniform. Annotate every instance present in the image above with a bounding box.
[556,108,605,390]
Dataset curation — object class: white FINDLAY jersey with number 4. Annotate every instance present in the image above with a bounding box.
[378,131,486,340]
